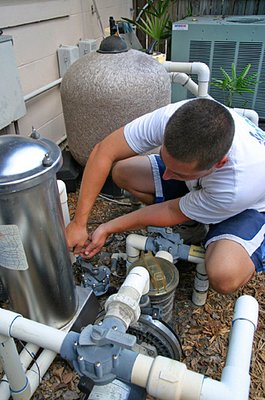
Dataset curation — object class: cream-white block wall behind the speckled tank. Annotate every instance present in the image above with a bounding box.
[0,0,132,142]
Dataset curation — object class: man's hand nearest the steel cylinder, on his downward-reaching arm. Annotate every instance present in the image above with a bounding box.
[65,220,88,256]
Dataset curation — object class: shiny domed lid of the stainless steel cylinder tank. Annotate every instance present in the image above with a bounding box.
[0,135,62,189]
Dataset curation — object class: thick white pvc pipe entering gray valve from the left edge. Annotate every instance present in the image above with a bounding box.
[0,308,66,353]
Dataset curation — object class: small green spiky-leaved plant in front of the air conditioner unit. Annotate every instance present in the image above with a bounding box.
[211,63,260,107]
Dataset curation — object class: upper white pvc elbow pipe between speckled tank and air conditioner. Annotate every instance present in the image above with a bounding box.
[163,61,210,97]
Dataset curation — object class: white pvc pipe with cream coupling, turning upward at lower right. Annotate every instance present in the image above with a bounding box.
[131,295,258,400]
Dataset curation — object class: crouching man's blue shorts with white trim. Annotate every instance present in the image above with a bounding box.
[148,154,265,272]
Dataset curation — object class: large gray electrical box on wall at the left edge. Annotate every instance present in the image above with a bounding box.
[0,35,26,129]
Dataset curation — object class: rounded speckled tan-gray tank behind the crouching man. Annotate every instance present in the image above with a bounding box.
[61,45,171,166]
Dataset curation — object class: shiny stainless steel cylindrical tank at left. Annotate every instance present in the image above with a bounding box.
[0,135,77,328]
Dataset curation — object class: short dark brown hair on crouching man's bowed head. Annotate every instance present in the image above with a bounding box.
[164,98,235,169]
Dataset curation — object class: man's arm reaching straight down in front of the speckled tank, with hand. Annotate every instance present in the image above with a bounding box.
[66,128,135,254]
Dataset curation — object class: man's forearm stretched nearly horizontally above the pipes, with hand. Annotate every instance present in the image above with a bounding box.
[81,199,190,258]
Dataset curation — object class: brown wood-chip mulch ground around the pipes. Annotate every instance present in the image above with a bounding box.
[17,191,265,400]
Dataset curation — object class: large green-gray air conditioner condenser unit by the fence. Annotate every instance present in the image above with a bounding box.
[171,15,265,119]
